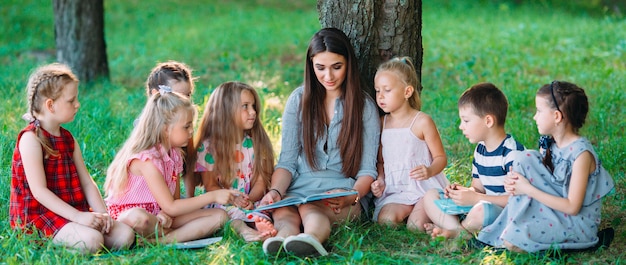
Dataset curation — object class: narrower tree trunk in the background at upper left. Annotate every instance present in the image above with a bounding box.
[53,0,109,82]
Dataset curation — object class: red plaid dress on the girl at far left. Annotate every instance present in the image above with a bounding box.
[9,123,89,237]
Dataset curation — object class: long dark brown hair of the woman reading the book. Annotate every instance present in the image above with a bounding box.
[302,28,365,177]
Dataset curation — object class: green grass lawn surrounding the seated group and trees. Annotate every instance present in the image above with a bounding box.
[0,0,626,264]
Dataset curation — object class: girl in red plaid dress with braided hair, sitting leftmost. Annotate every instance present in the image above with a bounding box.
[9,63,134,253]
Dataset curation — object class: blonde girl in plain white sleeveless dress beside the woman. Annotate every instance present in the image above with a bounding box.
[371,57,449,231]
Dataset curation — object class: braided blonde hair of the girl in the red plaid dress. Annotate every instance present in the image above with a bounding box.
[23,63,78,156]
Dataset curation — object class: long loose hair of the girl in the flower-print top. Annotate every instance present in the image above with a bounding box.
[194,82,274,188]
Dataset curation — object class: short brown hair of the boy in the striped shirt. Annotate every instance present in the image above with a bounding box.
[458,83,509,127]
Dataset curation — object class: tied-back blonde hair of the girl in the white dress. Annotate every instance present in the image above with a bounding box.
[377,56,422,110]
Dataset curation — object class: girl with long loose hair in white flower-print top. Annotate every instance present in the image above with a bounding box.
[195,82,276,242]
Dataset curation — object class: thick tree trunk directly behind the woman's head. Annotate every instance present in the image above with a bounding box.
[317,0,423,96]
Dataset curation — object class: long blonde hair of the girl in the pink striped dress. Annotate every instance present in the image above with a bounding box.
[104,91,196,196]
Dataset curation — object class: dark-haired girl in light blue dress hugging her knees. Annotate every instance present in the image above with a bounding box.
[478,81,614,252]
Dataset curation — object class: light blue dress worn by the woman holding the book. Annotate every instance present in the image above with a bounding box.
[276,87,380,210]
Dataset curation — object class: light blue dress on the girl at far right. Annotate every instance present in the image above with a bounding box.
[478,137,614,252]
